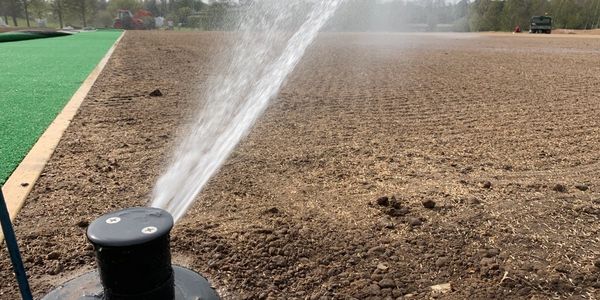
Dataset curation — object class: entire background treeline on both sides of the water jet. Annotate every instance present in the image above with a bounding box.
[0,0,600,31]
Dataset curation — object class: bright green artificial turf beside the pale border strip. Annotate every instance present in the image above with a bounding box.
[0,31,121,184]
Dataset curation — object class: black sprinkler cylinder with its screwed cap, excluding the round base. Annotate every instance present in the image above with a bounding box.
[87,207,175,300]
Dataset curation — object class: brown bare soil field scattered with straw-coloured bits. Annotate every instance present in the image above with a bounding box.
[0,31,600,299]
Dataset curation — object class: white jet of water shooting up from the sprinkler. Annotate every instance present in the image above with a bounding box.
[150,0,343,221]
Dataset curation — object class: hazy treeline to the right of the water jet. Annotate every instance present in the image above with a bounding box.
[329,0,600,31]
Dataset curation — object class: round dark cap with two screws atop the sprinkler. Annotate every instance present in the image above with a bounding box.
[87,207,173,247]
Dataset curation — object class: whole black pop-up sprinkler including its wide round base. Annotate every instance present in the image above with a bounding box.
[43,207,219,300]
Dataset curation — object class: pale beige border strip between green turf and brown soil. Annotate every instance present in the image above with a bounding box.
[0,31,125,227]
